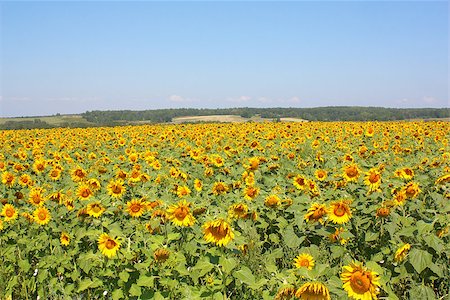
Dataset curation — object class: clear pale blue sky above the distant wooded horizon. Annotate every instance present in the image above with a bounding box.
[0,1,449,116]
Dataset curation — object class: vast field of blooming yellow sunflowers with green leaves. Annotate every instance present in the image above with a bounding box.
[0,121,450,300]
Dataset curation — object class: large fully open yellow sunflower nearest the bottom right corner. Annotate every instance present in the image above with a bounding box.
[341,262,380,300]
